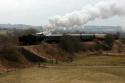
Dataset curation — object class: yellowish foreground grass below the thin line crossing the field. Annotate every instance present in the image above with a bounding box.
[0,67,125,83]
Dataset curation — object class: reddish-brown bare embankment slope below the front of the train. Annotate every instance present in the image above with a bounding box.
[21,44,70,61]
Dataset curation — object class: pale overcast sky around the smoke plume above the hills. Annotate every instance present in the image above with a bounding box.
[0,0,124,26]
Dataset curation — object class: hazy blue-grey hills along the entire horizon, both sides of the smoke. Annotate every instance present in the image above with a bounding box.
[0,24,122,33]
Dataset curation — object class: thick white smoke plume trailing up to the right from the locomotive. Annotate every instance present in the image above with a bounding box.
[44,0,125,32]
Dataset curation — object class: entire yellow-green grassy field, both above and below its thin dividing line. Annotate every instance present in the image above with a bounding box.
[0,56,125,83]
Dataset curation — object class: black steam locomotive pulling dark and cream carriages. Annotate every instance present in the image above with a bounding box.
[18,34,107,45]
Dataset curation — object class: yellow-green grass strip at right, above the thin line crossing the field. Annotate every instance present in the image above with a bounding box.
[72,54,125,66]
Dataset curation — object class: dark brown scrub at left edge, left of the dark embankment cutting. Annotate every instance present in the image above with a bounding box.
[0,35,29,67]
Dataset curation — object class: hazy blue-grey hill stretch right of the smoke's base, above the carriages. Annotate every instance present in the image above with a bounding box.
[54,25,122,33]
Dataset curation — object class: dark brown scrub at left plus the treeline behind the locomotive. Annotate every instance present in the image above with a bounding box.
[0,29,36,67]
